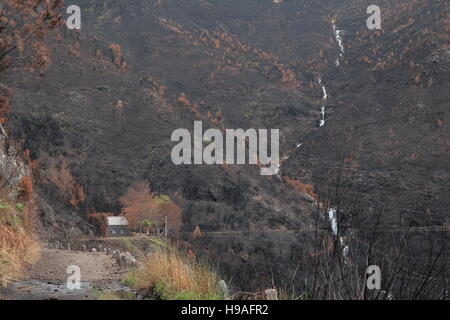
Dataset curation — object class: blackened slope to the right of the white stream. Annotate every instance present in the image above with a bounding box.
[290,1,450,225]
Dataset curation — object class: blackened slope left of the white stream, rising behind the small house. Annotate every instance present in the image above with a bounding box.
[10,1,334,287]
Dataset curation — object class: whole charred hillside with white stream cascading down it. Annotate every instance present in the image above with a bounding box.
[4,0,450,288]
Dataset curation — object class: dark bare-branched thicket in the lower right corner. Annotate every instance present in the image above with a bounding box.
[296,159,449,300]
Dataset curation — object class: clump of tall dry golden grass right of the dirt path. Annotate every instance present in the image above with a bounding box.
[132,249,221,300]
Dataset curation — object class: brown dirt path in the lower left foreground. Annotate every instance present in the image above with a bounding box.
[0,249,130,300]
